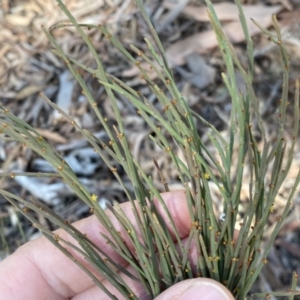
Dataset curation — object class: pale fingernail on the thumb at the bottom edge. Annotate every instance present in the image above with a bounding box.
[177,281,230,300]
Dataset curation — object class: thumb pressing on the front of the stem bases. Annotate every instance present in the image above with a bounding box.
[154,278,234,300]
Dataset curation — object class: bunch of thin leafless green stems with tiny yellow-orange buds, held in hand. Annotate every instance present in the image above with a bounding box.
[0,0,300,300]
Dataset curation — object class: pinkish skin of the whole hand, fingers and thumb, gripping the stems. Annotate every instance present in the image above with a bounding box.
[0,191,233,300]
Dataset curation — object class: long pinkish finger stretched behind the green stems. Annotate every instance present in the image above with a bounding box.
[0,191,190,299]
